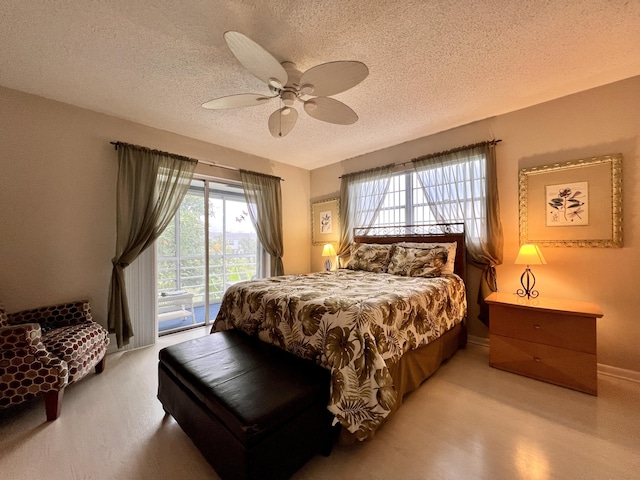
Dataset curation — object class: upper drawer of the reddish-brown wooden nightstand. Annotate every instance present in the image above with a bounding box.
[490,305,596,354]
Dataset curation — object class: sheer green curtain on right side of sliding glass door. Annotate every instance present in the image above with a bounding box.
[240,170,284,276]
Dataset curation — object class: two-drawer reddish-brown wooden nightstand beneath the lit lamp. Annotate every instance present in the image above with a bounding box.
[486,292,602,395]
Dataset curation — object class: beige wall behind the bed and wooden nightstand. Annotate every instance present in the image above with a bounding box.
[311,77,640,372]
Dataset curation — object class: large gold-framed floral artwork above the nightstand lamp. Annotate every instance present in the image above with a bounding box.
[518,154,622,247]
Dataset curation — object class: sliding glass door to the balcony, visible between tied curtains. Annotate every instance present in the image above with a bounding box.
[157,180,262,334]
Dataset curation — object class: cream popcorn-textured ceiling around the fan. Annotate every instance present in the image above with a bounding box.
[0,0,640,169]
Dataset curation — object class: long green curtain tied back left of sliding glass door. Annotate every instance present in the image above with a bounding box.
[108,143,198,348]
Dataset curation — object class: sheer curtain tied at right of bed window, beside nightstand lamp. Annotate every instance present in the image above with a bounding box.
[412,142,503,325]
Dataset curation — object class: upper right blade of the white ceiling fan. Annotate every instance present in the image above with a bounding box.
[300,61,369,97]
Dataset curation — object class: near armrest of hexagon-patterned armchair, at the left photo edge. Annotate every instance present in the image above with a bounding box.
[0,323,69,391]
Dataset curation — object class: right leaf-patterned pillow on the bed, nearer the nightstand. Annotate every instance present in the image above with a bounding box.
[387,245,447,277]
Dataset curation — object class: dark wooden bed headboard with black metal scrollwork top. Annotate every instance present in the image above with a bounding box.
[353,223,467,279]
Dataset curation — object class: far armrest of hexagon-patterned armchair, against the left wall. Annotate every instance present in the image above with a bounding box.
[7,300,92,330]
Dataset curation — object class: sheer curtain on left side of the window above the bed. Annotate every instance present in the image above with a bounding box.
[337,163,395,263]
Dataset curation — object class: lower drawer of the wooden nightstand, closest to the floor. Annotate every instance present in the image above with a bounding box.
[489,334,598,395]
